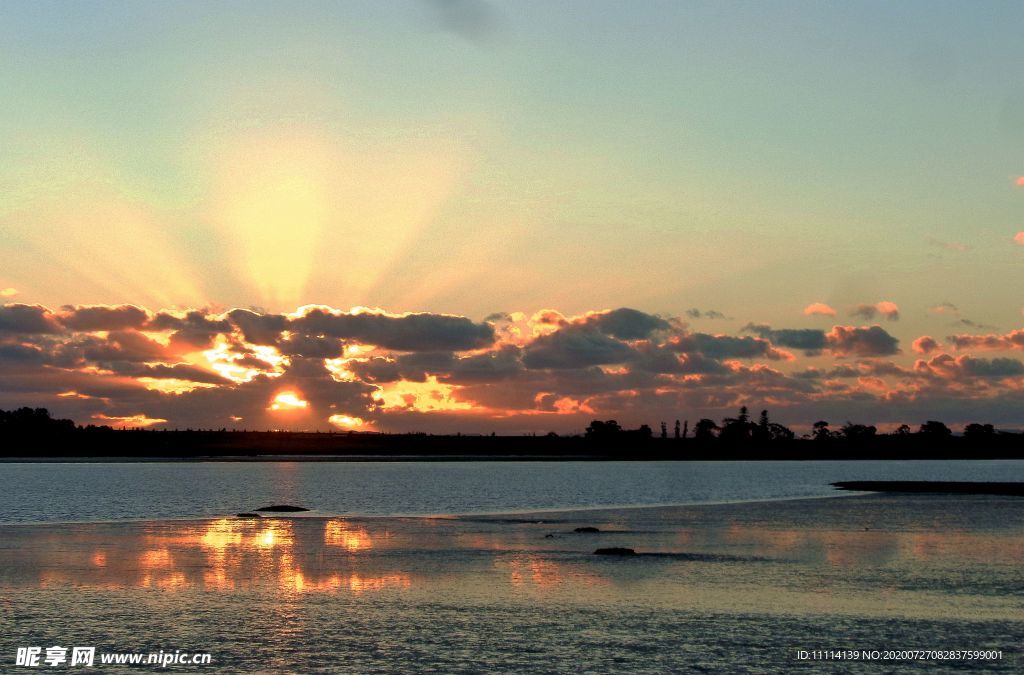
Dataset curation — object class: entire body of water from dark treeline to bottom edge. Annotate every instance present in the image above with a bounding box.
[0,461,1024,674]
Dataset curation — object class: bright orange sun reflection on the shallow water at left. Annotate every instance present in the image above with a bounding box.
[12,518,413,593]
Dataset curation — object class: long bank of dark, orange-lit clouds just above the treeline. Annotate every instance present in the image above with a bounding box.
[9,305,1024,433]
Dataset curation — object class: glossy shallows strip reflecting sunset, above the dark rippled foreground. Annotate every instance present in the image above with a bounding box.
[6,500,1024,620]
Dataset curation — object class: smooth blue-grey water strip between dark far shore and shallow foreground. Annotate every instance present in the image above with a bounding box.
[0,461,1024,522]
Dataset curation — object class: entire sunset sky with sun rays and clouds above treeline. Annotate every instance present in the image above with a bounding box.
[0,0,1024,433]
